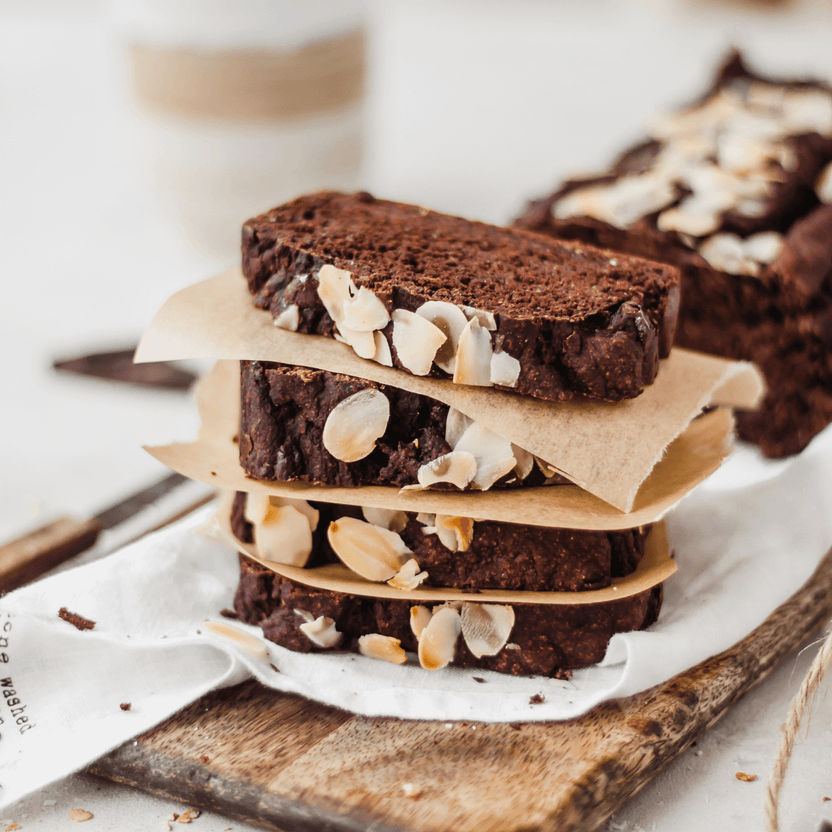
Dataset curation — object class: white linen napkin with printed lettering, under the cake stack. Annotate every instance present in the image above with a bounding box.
[0,429,832,809]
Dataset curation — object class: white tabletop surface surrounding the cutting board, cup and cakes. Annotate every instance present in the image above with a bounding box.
[0,0,832,832]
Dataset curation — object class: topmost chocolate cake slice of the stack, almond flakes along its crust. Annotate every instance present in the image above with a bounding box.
[243,192,679,401]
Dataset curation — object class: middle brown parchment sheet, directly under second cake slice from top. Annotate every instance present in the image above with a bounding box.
[146,361,733,530]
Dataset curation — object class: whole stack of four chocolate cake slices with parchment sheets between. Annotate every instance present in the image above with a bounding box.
[140,192,759,677]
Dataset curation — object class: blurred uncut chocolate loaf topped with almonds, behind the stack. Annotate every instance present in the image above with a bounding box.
[517,53,832,457]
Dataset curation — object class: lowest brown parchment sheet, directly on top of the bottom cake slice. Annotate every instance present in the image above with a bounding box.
[210,491,677,605]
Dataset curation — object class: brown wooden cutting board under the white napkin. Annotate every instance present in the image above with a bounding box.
[86,551,832,832]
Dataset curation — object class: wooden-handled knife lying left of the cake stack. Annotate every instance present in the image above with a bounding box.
[0,473,213,593]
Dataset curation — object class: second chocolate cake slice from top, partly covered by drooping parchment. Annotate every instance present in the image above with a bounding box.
[239,361,566,490]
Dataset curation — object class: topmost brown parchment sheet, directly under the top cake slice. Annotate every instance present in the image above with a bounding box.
[136,269,764,511]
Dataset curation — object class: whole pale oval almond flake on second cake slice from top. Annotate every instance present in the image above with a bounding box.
[322,388,390,462]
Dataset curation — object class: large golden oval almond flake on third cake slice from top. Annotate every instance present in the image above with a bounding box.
[327,517,412,581]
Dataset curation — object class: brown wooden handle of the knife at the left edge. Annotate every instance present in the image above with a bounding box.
[0,517,103,593]
